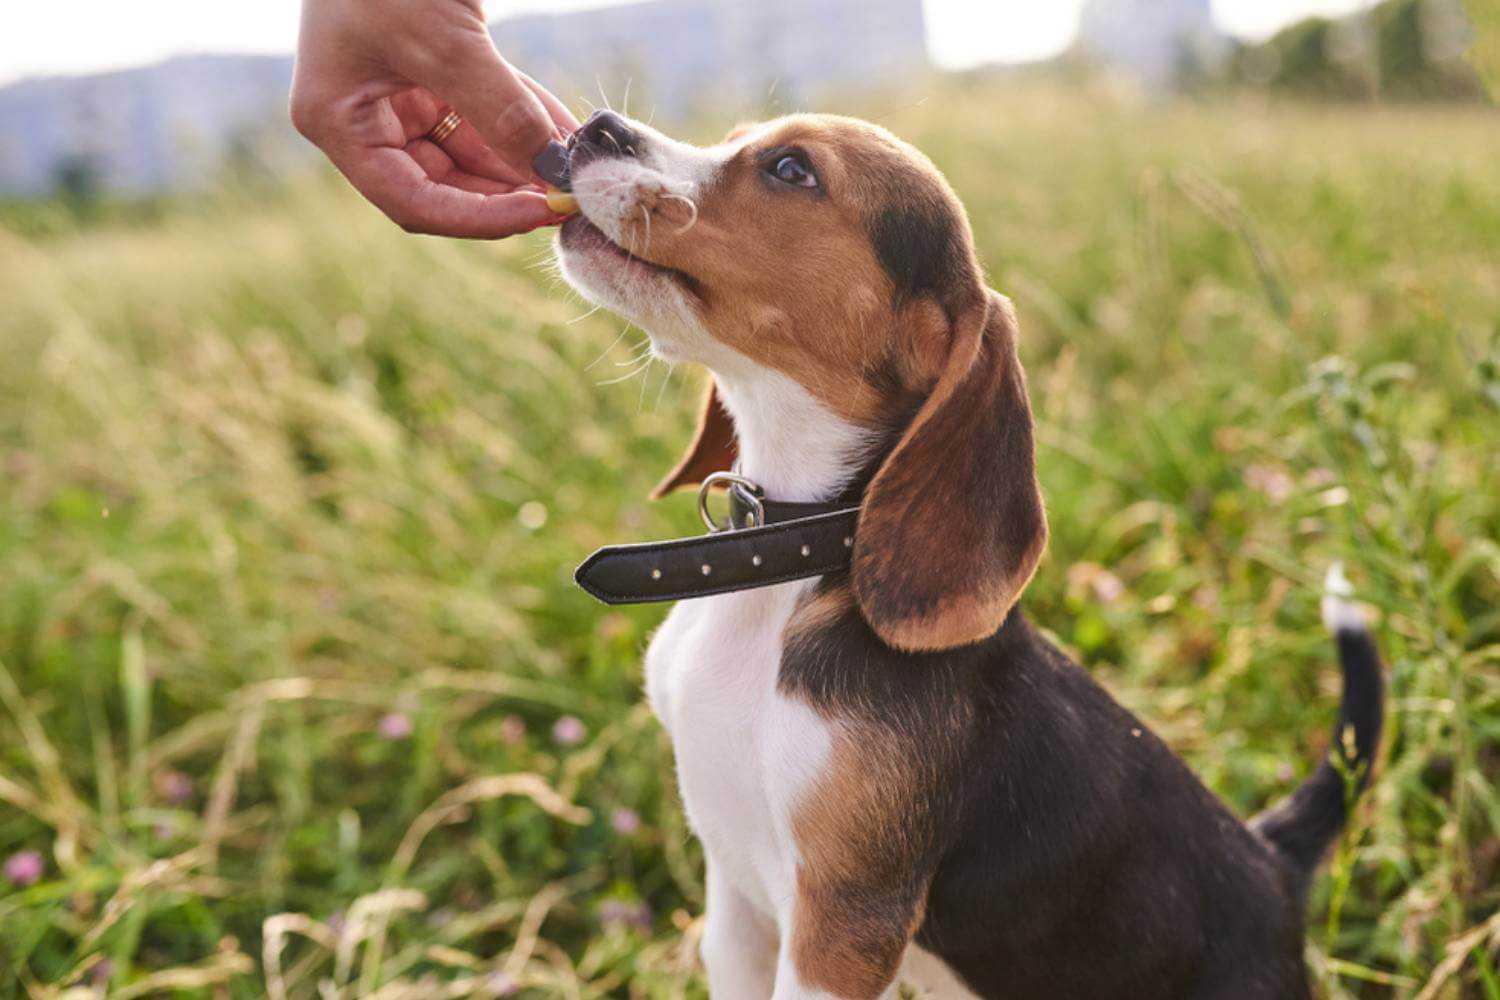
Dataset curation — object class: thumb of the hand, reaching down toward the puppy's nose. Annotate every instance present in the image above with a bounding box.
[416,31,557,177]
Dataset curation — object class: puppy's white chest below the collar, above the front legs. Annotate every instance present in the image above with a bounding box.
[647,583,833,918]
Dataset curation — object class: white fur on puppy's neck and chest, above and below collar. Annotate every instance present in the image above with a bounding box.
[647,373,867,999]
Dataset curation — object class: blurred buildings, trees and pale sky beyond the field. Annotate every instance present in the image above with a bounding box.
[0,0,1484,196]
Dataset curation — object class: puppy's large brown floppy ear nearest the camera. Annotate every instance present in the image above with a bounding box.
[852,292,1047,651]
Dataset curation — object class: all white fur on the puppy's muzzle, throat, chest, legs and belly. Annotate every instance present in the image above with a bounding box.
[560,115,972,1000]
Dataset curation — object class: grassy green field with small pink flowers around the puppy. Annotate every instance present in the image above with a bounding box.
[0,81,1500,1000]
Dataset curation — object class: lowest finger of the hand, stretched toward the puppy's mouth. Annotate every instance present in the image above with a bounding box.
[335,144,557,240]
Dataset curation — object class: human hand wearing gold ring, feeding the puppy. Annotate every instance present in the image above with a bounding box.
[291,0,578,238]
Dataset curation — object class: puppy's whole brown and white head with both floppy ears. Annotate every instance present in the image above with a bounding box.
[558,112,1047,649]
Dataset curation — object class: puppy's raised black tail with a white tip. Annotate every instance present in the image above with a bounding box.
[1251,562,1385,888]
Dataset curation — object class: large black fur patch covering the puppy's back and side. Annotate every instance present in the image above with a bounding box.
[779,599,1311,1000]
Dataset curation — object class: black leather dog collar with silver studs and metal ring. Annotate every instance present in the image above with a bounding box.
[573,472,860,604]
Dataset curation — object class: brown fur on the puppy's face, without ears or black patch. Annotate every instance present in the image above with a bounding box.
[629,115,960,426]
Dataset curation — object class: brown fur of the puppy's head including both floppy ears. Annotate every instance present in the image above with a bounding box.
[641,115,1047,649]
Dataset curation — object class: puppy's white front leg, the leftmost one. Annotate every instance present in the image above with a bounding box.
[698,858,777,1000]
